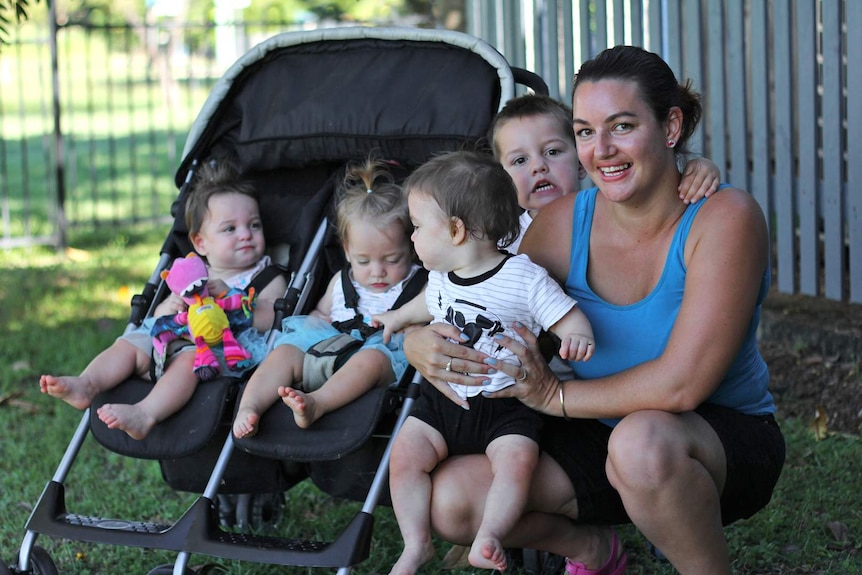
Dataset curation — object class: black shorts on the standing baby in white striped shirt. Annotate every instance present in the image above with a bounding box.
[410,380,542,455]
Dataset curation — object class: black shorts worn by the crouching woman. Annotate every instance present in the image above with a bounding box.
[541,405,785,525]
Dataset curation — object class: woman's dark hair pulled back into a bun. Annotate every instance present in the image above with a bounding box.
[572,46,703,154]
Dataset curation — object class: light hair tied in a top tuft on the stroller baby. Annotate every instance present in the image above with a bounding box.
[335,157,413,242]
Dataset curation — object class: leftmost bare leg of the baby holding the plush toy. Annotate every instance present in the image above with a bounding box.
[39,339,150,409]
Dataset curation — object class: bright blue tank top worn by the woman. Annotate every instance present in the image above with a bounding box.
[565,188,775,425]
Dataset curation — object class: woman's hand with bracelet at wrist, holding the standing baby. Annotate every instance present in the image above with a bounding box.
[485,323,562,415]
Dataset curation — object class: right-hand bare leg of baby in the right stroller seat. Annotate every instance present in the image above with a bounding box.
[278,349,395,429]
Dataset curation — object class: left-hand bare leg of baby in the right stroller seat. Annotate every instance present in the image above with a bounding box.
[233,344,305,438]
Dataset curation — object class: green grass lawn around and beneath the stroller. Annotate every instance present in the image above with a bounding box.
[0,229,862,575]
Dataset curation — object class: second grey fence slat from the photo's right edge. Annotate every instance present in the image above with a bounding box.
[821,2,859,300]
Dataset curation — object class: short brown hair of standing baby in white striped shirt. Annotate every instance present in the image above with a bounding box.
[404,151,523,248]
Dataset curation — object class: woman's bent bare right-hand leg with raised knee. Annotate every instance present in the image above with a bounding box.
[607,411,731,575]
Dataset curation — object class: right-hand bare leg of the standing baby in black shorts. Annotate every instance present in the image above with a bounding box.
[468,435,539,571]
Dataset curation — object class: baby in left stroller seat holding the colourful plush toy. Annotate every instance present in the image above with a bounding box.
[39,161,287,439]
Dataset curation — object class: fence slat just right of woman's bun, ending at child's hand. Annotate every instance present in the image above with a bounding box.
[704,0,727,173]
